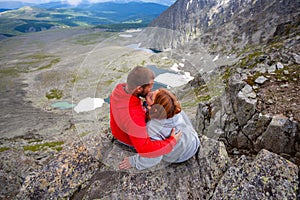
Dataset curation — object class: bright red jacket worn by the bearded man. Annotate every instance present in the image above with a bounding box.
[110,83,176,157]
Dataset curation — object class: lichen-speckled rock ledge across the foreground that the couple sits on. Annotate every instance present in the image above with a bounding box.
[17,133,298,199]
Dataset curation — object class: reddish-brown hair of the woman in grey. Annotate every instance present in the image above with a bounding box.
[147,88,181,121]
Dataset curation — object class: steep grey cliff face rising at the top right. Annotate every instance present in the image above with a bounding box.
[149,0,300,52]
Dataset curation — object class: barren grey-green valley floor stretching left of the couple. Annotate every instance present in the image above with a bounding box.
[0,28,203,198]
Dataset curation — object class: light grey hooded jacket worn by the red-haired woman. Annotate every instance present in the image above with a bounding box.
[129,111,200,170]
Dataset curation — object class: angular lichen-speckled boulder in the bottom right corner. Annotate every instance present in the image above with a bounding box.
[212,150,298,200]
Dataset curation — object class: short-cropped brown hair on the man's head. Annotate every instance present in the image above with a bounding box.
[127,66,155,90]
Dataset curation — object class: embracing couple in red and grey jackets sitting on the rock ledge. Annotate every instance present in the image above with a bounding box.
[110,66,200,170]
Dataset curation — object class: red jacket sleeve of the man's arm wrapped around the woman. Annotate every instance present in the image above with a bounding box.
[127,111,176,158]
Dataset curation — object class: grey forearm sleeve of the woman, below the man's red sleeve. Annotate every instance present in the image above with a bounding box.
[129,154,163,170]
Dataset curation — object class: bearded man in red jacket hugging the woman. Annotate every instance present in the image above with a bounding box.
[110,66,182,158]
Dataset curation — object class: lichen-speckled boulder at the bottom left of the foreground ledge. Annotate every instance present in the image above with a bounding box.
[17,146,99,200]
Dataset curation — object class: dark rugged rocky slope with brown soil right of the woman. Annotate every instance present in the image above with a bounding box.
[195,44,300,163]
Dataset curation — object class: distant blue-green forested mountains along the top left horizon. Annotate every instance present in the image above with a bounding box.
[0,2,168,35]
